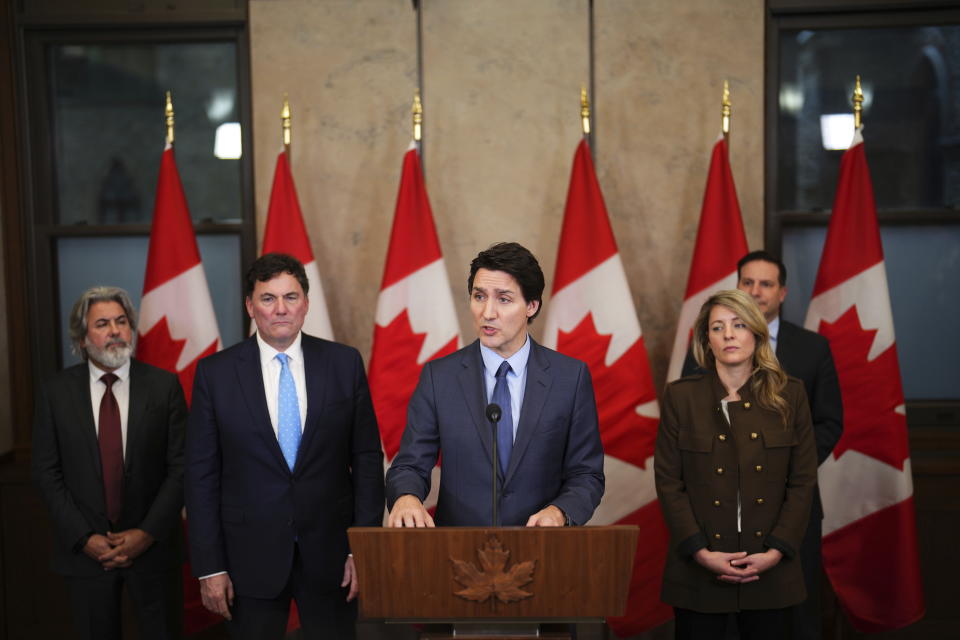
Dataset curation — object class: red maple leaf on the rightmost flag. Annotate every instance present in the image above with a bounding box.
[818,305,910,470]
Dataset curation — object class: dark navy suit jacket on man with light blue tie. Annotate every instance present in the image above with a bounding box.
[186,335,383,598]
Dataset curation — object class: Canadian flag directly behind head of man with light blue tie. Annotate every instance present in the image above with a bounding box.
[258,151,333,340]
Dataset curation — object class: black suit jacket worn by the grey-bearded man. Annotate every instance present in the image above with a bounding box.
[33,360,187,577]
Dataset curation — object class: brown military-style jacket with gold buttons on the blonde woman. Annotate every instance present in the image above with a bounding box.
[654,371,817,613]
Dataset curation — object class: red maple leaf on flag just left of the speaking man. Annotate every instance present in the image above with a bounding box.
[370,309,457,459]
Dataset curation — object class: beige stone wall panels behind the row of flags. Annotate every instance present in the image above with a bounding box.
[250,0,763,390]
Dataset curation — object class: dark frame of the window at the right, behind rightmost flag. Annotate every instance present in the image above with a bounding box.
[763,0,960,427]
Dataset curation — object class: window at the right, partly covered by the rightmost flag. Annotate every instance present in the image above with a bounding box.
[766,2,960,412]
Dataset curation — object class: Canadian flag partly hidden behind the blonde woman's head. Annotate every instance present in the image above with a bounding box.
[667,136,747,382]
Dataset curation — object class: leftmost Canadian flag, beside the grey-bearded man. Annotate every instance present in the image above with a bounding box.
[137,142,221,634]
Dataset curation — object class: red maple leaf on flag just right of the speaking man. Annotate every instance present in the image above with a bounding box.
[557,313,658,469]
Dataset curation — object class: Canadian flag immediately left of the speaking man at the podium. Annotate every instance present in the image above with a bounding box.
[369,144,460,496]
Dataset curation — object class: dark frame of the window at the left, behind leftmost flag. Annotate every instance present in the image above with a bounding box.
[19,25,256,383]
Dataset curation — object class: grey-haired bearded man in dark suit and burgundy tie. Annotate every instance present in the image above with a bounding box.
[33,287,187,640]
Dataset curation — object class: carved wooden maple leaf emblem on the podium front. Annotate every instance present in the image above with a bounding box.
[450,537,536,602]
